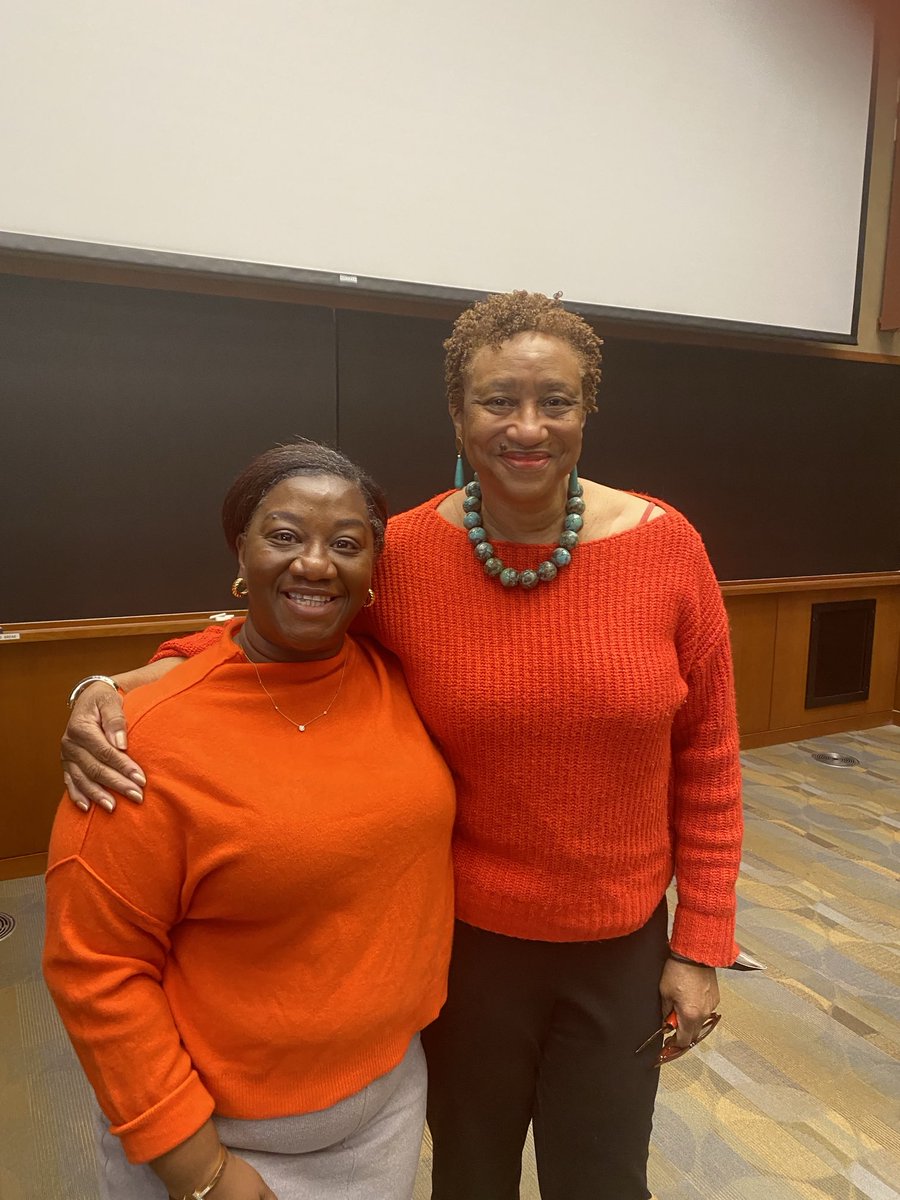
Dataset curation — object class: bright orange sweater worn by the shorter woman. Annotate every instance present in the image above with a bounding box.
[44,623,454,1162]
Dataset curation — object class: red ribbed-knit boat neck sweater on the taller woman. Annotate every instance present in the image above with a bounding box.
[157,492,742,966]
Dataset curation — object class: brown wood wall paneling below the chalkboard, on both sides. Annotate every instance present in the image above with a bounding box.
[0,585,900,878]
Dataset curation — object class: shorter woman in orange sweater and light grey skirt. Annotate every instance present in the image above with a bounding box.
[44,443,454,1200]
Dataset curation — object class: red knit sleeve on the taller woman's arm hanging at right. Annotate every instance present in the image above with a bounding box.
[671,542,743,966]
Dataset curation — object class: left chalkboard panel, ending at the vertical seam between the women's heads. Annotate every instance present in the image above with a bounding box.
[0,276,336,624]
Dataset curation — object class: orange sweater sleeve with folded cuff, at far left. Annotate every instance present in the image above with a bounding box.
[43,803,214,1162]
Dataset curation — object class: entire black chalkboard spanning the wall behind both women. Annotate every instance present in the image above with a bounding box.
[0,276,900,624]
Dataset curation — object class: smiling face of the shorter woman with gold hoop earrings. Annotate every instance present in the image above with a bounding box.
[238,475,374,662]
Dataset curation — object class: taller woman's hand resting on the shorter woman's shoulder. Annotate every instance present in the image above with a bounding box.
[60,683,146,812]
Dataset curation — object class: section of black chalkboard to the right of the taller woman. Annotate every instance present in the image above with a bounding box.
[588,340,900,580]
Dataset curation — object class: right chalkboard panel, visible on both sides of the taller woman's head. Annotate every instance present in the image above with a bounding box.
[337,312,900,580]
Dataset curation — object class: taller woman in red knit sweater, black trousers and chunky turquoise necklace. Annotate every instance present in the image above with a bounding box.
[60,293,742,1200]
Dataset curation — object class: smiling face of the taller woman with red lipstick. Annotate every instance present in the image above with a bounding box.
[450,332,587,502]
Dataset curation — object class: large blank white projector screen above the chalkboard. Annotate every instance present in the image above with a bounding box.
[0,0,874,340]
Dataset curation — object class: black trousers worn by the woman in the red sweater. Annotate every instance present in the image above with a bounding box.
[422,900,667,1200]
